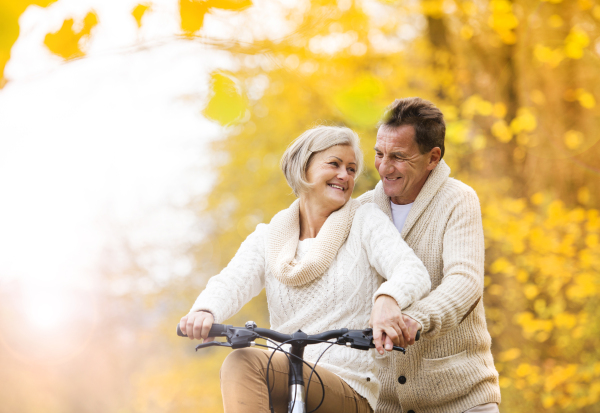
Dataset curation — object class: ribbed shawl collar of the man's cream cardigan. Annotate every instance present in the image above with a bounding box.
[373,159,450,238]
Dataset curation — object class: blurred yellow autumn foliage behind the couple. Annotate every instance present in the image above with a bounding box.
[0,0,600,412]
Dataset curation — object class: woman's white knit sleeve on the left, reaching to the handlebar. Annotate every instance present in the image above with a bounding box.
[190,224,267,323]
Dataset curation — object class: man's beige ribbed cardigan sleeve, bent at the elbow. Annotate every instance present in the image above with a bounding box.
[405,190,485,339]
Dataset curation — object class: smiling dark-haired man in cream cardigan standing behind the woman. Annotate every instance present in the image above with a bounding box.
[359,98,500,413]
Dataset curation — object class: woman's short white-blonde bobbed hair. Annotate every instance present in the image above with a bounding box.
[281,126,363,196]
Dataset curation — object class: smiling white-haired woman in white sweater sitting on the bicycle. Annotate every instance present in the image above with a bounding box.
[180,126,430,413]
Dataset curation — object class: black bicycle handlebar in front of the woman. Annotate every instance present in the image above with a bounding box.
[177,321,420,353]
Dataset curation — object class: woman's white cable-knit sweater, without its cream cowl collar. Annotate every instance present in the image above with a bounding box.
[191,204,431,409]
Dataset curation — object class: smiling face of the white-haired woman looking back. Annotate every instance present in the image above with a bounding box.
[301,145,358,212]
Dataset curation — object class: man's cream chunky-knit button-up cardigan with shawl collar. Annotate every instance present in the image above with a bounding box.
[359,160,500,413]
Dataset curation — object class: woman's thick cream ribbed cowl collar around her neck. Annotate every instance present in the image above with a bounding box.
[267,199,360,287]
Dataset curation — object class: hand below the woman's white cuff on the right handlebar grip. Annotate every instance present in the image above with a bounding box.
[369,295,416,354]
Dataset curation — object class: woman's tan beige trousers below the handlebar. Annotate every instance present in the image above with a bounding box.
[221,348,373,413]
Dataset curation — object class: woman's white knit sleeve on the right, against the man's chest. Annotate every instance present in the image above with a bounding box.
[361,204,431,308]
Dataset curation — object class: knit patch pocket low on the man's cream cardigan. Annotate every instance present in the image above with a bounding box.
[419,351,480,406]
